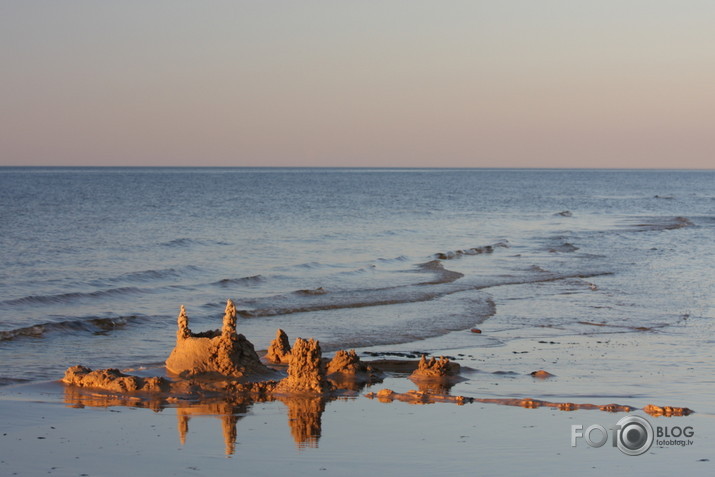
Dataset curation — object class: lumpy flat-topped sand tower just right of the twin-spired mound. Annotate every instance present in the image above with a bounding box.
[276,338,331,394]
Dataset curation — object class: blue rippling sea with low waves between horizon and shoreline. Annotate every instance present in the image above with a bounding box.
[0,168,715,384]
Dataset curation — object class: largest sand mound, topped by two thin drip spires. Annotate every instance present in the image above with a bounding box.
[166,300,271,377]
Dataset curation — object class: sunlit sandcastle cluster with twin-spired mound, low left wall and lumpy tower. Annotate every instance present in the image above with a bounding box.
[62,300,346,397]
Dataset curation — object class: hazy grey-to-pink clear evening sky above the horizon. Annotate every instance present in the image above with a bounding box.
[0,0,715,168]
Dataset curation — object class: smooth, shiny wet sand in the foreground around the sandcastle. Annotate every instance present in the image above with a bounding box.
[0,323,715,475]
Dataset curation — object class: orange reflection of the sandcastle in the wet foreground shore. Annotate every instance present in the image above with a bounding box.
[64,386,337,455]
